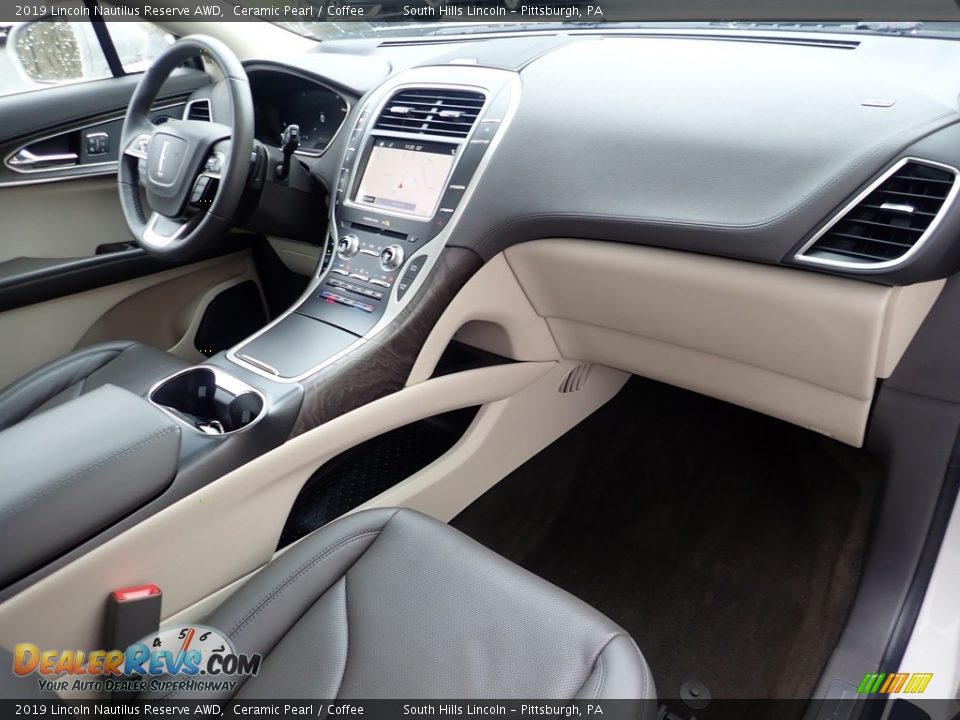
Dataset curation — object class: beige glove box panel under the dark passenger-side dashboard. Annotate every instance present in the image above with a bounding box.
[505,239,943,446]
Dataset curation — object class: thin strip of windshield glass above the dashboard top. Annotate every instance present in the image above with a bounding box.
[276,18,960,40]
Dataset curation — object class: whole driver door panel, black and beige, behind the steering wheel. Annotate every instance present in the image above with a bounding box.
[0,68,258,387]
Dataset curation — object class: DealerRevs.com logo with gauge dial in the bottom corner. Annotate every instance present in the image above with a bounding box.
[13,625,263,692]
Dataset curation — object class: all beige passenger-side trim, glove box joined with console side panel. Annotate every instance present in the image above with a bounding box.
[0,240,943,672]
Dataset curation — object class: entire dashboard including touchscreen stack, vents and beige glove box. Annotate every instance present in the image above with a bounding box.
[201,31,960,445]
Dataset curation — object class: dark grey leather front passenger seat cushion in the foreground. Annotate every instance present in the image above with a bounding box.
[146,508,656,700]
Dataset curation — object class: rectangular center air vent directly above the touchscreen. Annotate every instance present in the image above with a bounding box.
[374,88,484,138]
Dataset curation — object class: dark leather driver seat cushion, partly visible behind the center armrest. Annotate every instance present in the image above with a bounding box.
[0,341,190,431]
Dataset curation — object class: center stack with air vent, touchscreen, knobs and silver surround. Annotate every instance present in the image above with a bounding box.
[296,67,512,336]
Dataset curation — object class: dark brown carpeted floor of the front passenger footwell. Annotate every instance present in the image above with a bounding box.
[451,378,879,698]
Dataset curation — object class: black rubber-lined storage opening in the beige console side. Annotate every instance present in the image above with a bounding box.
[278,408,477,547]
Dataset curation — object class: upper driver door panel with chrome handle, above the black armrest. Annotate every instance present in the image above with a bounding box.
[0,69,209,270]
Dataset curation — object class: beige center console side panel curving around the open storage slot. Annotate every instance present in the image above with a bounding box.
[0,361,629,699]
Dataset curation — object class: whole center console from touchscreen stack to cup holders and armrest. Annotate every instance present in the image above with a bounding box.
[0,65,519,601]
